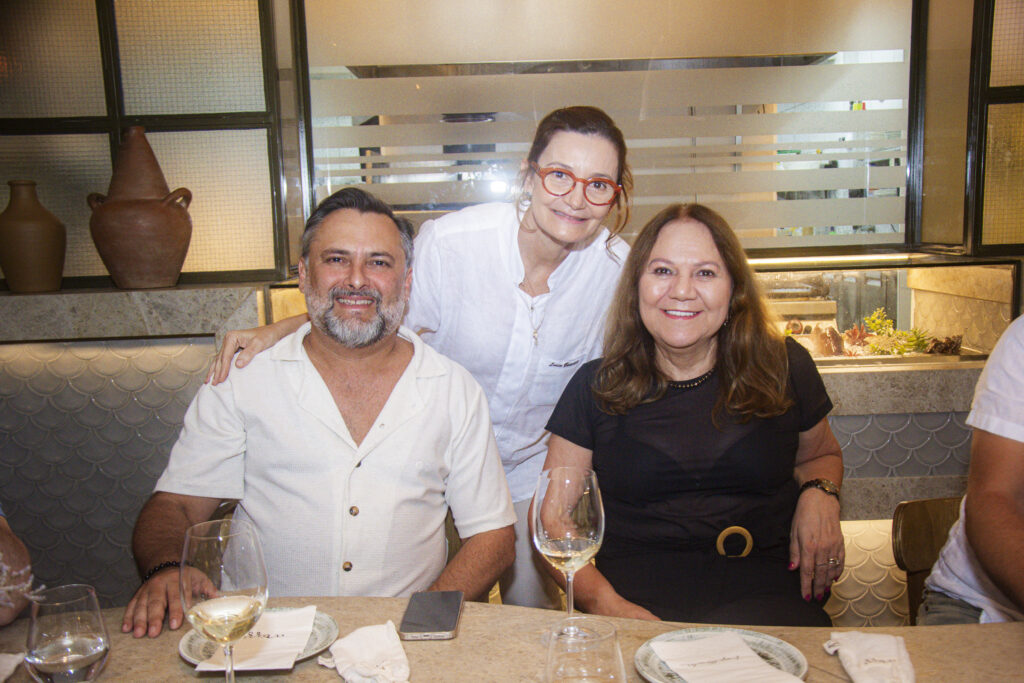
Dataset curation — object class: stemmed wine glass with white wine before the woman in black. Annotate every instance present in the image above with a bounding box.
[530,467,604,634]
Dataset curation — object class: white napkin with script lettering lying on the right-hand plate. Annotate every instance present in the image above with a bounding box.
[650,631,800,683]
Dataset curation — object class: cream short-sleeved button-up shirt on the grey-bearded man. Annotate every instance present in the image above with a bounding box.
[156,324,515,596]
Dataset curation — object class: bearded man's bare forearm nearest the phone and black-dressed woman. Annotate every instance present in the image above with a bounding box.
[430,524,515,600]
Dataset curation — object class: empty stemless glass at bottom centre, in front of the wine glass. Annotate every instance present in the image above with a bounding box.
[544,616,626,683]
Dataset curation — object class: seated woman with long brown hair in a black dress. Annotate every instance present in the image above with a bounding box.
[545,204,844,626]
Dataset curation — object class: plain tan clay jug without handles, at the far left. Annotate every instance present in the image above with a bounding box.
[0,180,68,292]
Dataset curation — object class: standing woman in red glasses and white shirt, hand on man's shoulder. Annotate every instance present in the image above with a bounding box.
[210,106,633,608]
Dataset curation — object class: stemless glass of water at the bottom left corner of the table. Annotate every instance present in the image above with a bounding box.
[25,584,111,683]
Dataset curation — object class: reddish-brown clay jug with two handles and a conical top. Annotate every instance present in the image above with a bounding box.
[88,126,191,290]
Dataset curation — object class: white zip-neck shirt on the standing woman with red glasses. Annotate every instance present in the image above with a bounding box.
[406,204,629,502]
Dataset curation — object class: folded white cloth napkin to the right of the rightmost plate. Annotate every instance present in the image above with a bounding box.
[825,631,913,683]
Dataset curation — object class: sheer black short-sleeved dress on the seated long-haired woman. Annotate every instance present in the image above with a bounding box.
[548,339,831,625]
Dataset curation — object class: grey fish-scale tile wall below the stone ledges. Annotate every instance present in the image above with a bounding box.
[0,337,970,606]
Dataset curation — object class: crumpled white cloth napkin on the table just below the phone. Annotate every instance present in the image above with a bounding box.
[317,622,409,683]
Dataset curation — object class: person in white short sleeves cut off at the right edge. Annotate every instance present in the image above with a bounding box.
[918,316,1024,626]
